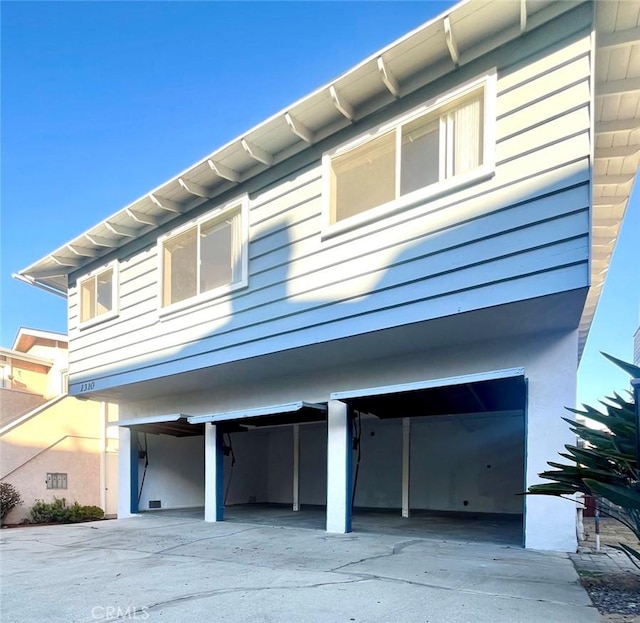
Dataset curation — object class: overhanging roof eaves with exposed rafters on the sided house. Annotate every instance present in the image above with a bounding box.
[16,0,640,358]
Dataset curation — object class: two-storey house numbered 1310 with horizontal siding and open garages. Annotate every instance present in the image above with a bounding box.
[18,0,640,551]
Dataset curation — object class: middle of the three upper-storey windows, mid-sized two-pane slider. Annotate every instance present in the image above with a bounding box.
[159,198,247,308]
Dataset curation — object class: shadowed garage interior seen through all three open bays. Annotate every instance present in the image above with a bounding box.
[132,376,526,546]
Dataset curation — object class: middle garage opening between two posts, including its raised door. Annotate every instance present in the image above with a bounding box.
[189,401,327,529]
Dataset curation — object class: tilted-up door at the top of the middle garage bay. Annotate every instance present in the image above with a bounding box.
[188,401,327,426]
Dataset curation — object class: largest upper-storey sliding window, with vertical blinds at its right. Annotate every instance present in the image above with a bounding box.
[324,72,495,235]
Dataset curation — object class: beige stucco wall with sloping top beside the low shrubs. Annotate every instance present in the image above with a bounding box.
[0,397,116,523]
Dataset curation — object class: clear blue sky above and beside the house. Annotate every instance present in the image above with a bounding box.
[0,2,640,408]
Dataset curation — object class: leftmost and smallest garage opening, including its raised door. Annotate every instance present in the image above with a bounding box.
[118,414,204,516]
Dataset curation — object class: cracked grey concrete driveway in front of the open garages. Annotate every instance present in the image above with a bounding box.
[0,514,601,623]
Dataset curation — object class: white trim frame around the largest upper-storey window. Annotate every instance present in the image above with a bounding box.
[322,67,497,239]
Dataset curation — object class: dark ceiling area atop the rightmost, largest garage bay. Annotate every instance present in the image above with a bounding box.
[343,376,525,418]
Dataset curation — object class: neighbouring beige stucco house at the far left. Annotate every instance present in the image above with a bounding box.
[0,328,118,523]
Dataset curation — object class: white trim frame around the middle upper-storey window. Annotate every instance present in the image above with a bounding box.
[157,194,249,319]
